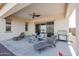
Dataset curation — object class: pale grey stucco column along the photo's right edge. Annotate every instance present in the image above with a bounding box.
[76,4,79,55]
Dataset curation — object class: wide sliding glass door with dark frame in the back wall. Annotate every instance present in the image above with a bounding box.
[36,22,54,37]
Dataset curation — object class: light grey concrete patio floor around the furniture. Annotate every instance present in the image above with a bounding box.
[0,38,72,56]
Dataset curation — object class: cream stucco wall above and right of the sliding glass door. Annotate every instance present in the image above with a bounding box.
[32,16,69,34]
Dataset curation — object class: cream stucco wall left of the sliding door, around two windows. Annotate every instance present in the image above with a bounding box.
[0,19,35,40]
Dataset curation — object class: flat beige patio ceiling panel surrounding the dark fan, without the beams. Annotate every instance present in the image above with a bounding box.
[14,3,65,19]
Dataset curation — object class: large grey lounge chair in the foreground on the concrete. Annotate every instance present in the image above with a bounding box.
[34,36,56,51]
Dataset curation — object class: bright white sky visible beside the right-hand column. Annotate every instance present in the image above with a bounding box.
[69,9,76,28]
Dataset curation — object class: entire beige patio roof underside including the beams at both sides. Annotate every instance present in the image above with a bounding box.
[0,3,74,20]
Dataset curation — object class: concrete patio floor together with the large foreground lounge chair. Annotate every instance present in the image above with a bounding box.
[0,31,71,56]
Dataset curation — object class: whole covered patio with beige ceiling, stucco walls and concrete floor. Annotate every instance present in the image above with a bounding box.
[0,3,75,56]
